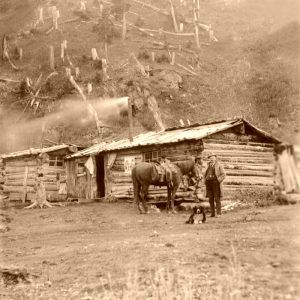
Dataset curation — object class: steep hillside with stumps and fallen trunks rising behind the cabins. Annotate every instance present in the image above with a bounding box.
[0,0,300,152]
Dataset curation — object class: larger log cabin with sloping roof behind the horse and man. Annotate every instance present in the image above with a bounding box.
[67,119,294,200]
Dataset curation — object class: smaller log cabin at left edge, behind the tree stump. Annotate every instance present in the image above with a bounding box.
[1,144,78,204]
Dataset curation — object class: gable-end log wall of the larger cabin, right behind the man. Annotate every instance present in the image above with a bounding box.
[203,137,276,196]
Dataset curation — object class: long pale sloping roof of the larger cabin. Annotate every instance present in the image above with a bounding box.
[67,119,281,158]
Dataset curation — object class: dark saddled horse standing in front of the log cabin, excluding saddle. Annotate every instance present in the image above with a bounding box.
[131,159,201,213]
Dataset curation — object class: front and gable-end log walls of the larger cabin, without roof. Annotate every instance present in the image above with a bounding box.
[106,132,276,199]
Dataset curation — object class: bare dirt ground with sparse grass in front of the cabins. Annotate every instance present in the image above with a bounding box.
[0,203,300,300]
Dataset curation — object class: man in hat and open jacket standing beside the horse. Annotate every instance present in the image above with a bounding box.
[204,154,226,218]
